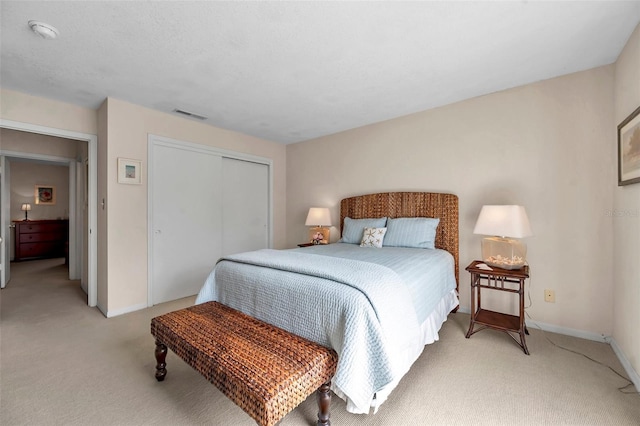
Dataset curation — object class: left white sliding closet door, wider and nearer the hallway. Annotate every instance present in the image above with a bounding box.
[149,143,222,305]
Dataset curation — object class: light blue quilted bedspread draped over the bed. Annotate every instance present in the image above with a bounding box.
[196,244,455,413]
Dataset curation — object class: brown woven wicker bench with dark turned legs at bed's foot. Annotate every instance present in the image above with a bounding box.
[151,302,338,426]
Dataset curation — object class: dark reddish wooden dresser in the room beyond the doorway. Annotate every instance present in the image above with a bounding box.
[13,220,69,262]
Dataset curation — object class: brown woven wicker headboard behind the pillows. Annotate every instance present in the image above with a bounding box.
[340,192,460,284]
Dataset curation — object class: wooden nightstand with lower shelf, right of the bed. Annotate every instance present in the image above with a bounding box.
[465,260,529,355]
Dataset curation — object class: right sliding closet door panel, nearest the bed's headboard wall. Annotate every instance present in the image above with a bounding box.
[222,157,269,255]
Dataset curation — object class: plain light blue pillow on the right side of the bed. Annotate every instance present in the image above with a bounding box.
[382,217,440,249]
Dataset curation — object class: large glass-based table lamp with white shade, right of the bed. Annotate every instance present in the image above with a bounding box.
[473,205,533,269]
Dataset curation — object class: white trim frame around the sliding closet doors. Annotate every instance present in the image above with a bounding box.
[147,133,273,307]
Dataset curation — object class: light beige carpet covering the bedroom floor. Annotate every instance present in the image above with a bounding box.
[0,259,640,426]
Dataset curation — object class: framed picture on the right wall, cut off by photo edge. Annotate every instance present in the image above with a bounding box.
[618,107,640,186]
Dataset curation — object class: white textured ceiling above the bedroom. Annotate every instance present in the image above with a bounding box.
[0,0,640,143]
